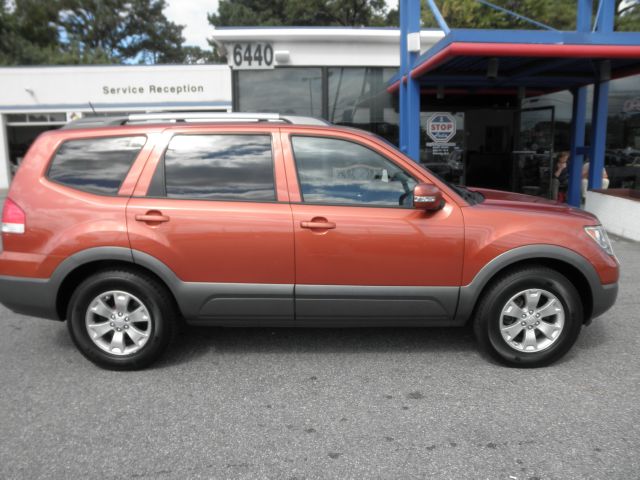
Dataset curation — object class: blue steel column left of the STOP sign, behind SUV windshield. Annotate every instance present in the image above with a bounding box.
[405,0,420,162]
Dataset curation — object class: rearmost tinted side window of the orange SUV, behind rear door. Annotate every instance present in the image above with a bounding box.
[47,136,147,195]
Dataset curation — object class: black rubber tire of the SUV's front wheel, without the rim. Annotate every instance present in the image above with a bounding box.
[473,266,584,368]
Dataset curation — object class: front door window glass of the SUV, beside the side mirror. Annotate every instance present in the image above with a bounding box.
[291,136,416,207]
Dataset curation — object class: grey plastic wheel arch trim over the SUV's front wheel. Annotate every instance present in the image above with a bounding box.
[455,245,600,324]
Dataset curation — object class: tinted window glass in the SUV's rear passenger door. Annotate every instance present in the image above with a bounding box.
[164,135,276,202]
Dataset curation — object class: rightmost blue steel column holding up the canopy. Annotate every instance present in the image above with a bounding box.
[589,0,616,190]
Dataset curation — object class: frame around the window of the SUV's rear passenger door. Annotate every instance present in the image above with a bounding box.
[146,131,284,203]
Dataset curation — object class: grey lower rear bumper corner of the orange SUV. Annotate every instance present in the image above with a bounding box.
[0,276,60,320]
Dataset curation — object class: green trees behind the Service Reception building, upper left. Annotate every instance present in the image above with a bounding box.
[0,0,205,65]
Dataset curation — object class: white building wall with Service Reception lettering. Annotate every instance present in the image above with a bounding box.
[0,65,231,113]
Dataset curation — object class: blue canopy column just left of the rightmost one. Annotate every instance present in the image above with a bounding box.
[567,0,593,207]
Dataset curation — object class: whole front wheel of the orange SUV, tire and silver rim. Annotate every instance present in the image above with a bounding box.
[474,267,584,367]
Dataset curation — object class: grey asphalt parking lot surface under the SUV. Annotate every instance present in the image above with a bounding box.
[0,235,640,480]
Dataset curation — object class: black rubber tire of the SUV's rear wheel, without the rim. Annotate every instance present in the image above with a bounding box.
[67,269,178,370]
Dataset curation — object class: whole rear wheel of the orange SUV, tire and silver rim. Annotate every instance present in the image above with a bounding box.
[67,270,177,370]
